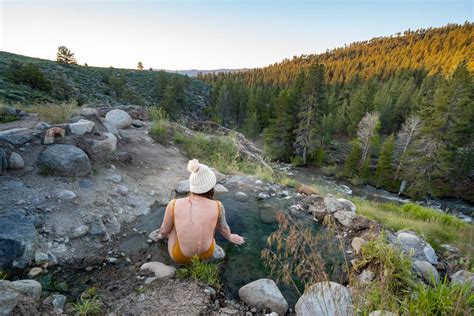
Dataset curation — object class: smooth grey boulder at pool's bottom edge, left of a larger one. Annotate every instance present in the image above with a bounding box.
[239,279,288,315]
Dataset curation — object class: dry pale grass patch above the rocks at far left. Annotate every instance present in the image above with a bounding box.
[21,102,79,124]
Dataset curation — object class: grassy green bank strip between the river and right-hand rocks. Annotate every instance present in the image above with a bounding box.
[351,197,474,254]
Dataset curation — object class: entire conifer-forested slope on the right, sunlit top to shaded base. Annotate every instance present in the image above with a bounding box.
[199,23,474,201]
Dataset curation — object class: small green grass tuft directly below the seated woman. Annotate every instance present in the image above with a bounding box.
[176,256,221,288]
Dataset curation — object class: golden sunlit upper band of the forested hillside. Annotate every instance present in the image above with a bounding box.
[203,22,474,86]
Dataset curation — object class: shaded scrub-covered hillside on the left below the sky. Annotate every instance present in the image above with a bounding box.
[0,52,210,117]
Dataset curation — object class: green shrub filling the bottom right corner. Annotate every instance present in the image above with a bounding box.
[406,279,474,315]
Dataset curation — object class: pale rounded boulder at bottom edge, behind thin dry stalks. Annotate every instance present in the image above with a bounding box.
[295,281,353,316]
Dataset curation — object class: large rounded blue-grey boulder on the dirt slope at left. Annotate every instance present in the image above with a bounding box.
[38,144,91,177]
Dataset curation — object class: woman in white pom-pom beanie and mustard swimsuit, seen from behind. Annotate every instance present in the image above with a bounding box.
[151,159,245,264]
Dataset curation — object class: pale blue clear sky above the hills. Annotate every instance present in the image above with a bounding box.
[0,0,473,70]
